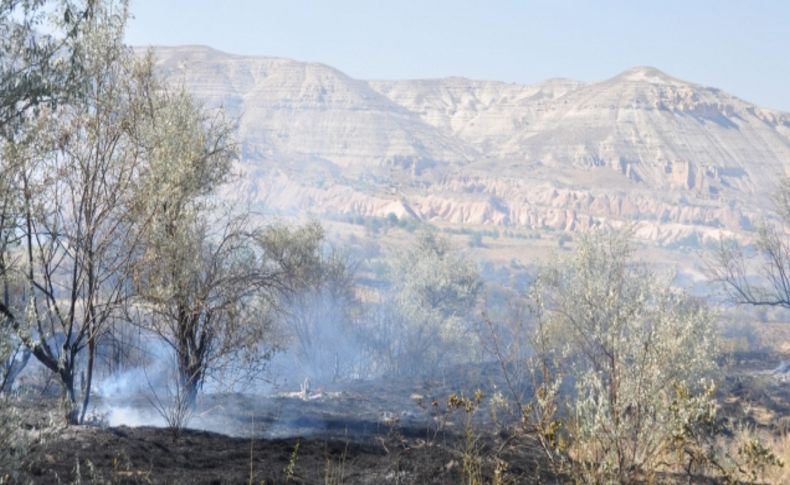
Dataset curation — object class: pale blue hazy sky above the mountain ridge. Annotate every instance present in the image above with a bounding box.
[127,0,790,111]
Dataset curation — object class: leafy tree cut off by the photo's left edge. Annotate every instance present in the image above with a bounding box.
[0,0,94,398]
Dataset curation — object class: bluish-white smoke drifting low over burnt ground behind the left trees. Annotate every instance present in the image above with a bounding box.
[79,229,508,437]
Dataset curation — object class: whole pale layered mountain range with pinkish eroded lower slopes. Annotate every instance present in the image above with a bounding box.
[150,46,790,244]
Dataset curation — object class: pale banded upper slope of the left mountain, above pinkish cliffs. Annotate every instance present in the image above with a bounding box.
[156,47,471,171]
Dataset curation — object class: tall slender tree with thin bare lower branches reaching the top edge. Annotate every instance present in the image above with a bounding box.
[0,2,153,423]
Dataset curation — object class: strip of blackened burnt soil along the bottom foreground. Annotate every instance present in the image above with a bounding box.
[21,426,554,484]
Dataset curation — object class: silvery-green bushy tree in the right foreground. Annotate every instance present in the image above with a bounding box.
[529,234,716,483]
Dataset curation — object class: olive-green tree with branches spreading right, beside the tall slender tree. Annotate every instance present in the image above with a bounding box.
[133,84,323,406]
